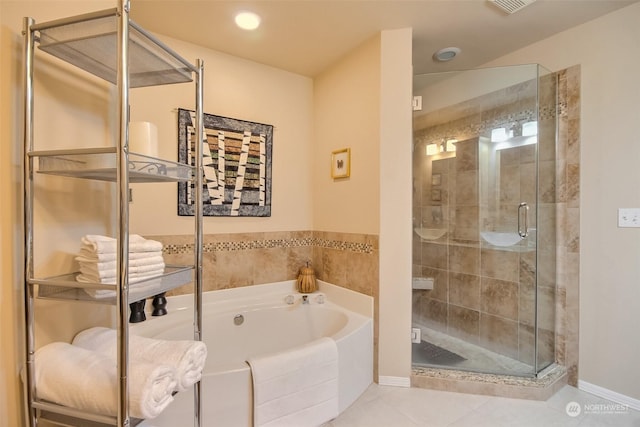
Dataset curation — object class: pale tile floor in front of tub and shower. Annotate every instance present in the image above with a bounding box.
[323,384,640,427]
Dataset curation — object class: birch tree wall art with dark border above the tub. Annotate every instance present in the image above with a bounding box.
[178,108,273,217]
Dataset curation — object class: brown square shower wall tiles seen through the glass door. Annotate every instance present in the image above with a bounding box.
[413,138,553,364]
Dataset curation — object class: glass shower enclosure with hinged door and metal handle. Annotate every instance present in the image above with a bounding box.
[412,64,557,377]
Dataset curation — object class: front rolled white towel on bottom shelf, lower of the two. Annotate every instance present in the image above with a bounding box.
[35,342,176,418]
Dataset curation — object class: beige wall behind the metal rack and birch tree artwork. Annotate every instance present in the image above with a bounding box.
[0,0,313,427]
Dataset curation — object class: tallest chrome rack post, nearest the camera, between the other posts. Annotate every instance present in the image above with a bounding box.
[116,0,130,427]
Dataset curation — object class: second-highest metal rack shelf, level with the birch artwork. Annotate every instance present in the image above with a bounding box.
[29,147,193,183]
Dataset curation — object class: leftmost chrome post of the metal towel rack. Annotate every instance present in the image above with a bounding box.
[22,18,38,427]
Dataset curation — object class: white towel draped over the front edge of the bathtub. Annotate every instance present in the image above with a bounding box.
[247,337,338,427]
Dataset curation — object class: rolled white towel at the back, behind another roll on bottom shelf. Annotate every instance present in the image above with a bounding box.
[73,326,207,391]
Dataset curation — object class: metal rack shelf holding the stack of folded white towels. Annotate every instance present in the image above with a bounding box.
[29,266,193,305]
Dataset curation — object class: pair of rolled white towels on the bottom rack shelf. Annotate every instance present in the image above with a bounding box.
[35,327,207,418]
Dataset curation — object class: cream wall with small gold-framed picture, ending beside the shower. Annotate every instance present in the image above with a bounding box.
[313,29,413,385]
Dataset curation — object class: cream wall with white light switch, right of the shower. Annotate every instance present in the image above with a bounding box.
[486,3,640,399]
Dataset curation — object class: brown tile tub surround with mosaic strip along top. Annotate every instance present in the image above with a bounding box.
[150,231,378,297]
